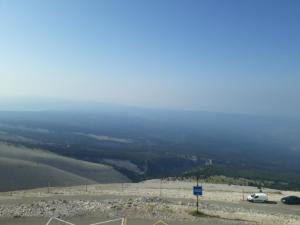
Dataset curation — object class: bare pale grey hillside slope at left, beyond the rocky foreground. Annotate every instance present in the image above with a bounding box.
[0,143,129,191]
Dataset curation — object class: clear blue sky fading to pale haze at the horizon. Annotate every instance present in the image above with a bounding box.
[0,0,300,116]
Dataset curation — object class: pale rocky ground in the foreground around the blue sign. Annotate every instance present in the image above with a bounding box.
[0,180,300,225]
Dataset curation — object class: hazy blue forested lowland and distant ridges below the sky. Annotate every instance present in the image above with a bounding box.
[0,103,300,189]
